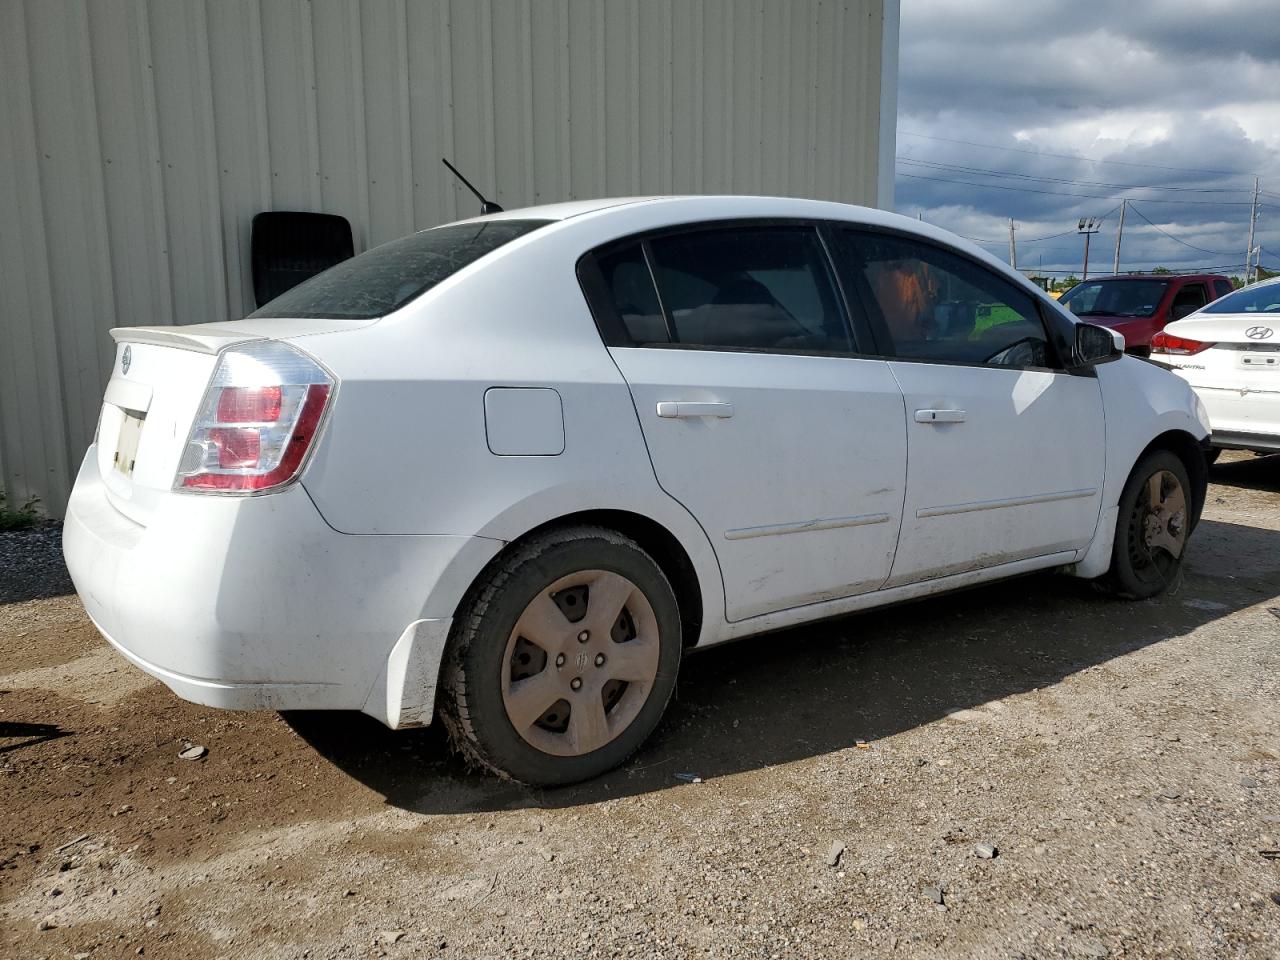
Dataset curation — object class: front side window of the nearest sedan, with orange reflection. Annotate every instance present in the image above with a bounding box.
[841,230,1055,367]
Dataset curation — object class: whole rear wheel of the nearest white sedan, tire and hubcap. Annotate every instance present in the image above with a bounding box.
[440,526,682,787]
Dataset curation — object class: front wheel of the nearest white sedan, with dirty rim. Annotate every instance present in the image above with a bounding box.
[1106,451,1193,600]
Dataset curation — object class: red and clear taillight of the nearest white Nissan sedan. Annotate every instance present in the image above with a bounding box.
[180,342,335,493]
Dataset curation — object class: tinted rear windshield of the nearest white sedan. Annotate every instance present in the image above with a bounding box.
[250,220,550,320]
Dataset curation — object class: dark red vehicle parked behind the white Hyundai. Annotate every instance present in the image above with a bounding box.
[1059,274,1231,357]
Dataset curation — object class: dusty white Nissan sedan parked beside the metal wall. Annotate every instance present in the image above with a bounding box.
[64,197,1208,785]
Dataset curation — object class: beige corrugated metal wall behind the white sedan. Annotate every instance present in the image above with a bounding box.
[0,0,896,515]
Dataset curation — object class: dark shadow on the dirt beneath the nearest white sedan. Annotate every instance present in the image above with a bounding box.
[285,521,1280,814]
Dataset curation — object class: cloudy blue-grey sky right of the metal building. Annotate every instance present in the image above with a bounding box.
[896,0,1280,275]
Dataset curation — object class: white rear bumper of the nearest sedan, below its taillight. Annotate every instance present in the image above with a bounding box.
[63,448,502,726]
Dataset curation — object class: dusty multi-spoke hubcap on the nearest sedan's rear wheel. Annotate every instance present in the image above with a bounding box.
[502,570,659,756]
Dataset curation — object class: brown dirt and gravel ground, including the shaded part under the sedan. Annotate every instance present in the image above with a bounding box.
[0,454,1280,960]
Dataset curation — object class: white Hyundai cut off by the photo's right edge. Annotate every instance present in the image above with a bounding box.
[1151,278,1280,453]
